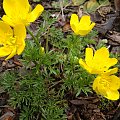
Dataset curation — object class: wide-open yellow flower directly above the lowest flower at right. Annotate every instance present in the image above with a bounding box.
[79,47,118,75]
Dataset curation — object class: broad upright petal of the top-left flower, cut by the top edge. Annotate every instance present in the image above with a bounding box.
[3,0,30,18]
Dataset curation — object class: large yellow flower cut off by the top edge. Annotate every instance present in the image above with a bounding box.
[2,0,44,27]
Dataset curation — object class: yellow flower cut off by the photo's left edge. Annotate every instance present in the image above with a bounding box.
[0,21,26,60]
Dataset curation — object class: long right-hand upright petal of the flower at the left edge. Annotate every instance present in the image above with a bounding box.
[14,24,26,55]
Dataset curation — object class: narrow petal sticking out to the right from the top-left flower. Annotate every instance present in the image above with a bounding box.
[27,4,44,22]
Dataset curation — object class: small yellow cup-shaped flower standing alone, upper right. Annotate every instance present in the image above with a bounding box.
[70,14,95,36]
